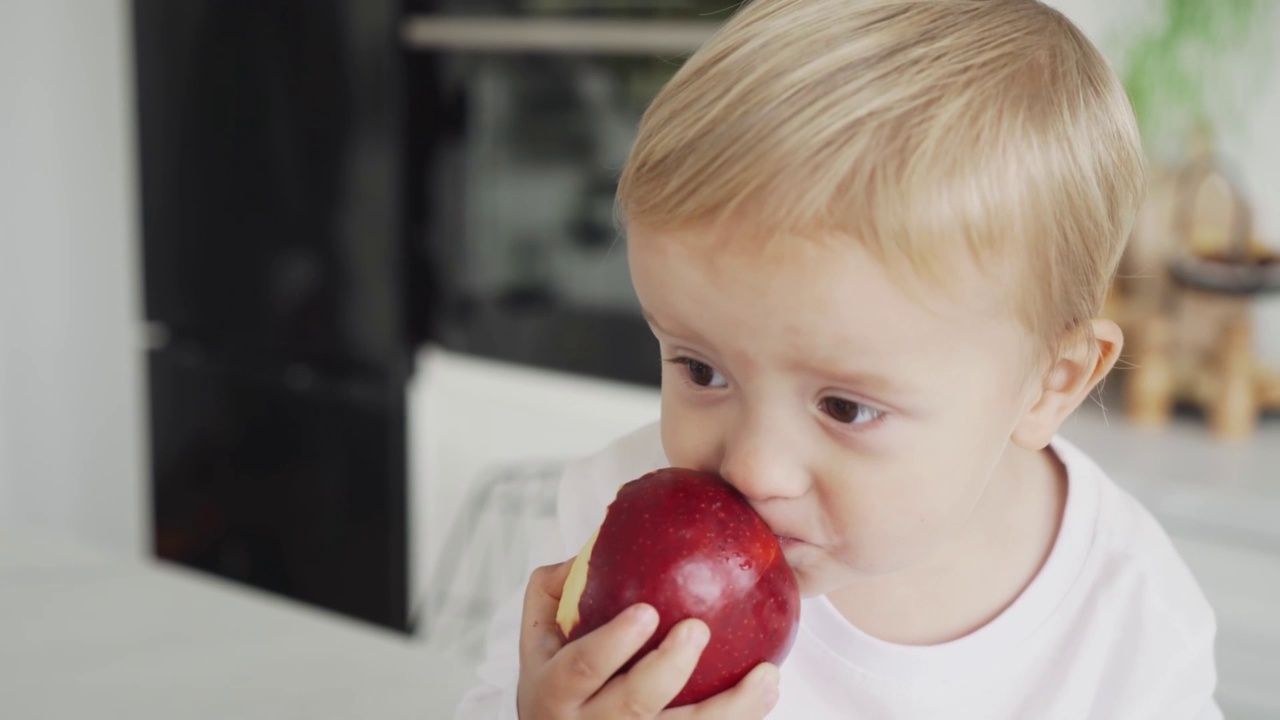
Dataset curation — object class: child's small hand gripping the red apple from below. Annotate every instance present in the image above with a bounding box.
[517,561,778,720]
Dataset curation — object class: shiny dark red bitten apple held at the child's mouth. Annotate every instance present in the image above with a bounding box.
[557,468,800,707]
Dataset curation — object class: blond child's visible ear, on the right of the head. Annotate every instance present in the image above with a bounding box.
[1012,319,1124,450]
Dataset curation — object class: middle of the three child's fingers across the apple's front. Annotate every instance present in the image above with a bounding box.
[590,619,711,717]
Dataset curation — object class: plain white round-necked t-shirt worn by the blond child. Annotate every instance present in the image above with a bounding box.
[456,425,1222,720]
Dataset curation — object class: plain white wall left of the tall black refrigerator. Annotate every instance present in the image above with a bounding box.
[0,0,147,552]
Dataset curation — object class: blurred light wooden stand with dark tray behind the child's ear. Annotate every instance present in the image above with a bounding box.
[1106,131,1280,439]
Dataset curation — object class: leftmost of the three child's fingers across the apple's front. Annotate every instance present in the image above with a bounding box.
[544,603,658,702]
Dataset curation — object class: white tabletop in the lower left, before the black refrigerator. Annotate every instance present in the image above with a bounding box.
[0,520,472,720]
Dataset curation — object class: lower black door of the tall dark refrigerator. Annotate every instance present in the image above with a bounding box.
[148,346,408,629]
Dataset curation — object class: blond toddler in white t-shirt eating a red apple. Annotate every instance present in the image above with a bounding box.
[458,0,1221,720]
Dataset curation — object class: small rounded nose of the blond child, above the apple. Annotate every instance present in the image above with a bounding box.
[719,415,809,502]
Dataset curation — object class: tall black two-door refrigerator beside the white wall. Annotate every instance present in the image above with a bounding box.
[133,0,431,630]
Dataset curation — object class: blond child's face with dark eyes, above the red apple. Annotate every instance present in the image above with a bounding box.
[628,221,1036,596]
